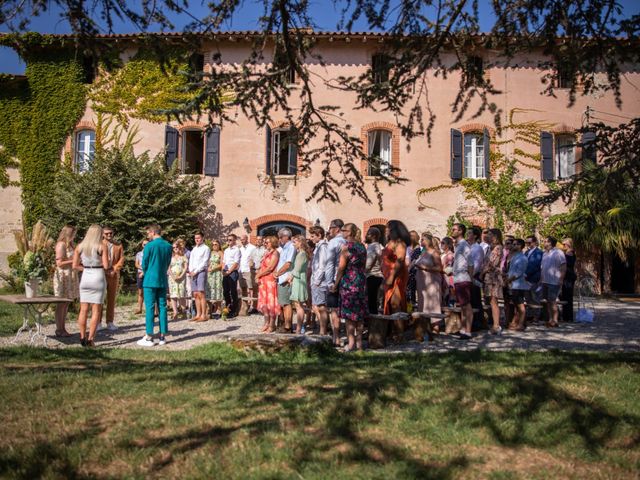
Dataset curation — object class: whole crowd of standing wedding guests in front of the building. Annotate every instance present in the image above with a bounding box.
[54,219,576,350]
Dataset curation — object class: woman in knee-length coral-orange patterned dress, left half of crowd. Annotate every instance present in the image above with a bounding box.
[256,236,280,333]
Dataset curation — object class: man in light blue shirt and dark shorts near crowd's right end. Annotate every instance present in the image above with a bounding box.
[541,237,567,327]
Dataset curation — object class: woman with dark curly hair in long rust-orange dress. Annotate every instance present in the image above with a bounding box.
[382,220,411,340]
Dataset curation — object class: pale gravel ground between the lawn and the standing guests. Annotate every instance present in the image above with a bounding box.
[0,300,640,353]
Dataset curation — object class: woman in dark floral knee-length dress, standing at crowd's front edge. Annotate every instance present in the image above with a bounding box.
[333,223,369,352]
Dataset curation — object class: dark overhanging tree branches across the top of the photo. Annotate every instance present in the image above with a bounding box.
[0,0,640,207]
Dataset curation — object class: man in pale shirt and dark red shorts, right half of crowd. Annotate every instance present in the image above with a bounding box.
[451,223,473,340]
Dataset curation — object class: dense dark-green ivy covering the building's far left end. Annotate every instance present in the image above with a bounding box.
[0,34,86,226]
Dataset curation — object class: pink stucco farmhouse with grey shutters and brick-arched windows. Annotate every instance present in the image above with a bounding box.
[0,31,640,292]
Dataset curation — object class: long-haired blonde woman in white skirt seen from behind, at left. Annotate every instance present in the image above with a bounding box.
[73,225,109,347]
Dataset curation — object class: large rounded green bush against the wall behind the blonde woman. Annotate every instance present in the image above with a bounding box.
[46,142,214,279]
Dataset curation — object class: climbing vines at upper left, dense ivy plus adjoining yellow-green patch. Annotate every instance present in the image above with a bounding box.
[0,33,211,226]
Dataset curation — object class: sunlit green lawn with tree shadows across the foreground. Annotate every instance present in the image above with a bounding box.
[0,345,640,479]
